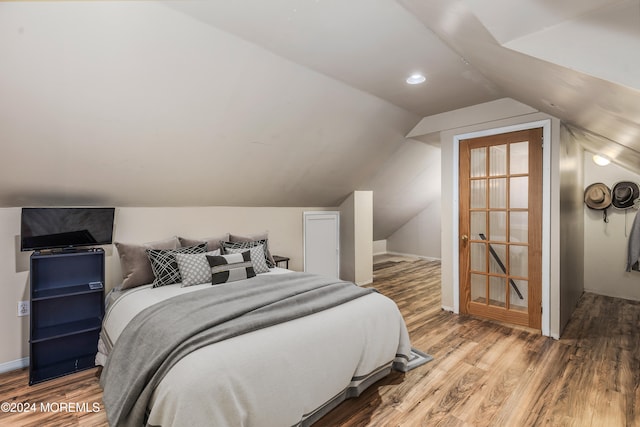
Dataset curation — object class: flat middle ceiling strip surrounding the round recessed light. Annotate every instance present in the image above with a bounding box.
[165,0,501,117]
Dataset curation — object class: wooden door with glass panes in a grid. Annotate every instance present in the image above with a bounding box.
[459,128,542,329]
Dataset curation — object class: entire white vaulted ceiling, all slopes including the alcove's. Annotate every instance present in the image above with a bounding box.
[0,0,640,238]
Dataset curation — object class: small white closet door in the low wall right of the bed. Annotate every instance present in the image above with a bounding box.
[304,211,340,277]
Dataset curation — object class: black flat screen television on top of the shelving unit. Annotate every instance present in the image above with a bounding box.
[20,208,115,251]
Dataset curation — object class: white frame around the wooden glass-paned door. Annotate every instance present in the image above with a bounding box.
[452,119,551,336]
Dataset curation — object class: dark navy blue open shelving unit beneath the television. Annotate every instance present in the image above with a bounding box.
[29,249,104,385]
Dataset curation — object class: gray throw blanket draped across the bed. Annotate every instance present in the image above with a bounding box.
[100,273,374,427]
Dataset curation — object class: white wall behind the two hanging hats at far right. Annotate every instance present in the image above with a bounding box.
[583,151,640,301]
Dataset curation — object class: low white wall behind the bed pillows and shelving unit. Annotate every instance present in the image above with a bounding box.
[0,207,336,371]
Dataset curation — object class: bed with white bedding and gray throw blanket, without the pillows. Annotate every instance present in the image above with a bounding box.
[96,236,411,426]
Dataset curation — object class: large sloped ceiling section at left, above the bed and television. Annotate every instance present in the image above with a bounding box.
[0,1,419,211]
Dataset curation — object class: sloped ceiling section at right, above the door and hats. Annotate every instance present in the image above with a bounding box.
[399,0,640,170]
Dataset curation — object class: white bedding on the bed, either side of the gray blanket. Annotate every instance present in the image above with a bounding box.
[96,269,410,427]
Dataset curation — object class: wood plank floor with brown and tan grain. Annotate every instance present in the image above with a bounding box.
[0,260,640,427]
